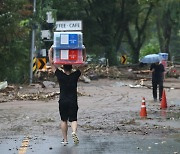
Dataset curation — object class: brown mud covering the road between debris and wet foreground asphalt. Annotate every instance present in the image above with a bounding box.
[0,79,180,140]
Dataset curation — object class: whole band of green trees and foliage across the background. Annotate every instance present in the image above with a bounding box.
[0,0,180,82]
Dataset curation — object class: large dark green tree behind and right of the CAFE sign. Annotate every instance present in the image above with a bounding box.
[51,0,134,65]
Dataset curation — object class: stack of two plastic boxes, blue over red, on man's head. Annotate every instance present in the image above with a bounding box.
[53,32,84,64]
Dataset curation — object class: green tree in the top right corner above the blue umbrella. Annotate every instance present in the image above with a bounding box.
[155,0,180,58]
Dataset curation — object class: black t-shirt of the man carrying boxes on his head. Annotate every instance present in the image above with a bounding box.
[55,69,81,102]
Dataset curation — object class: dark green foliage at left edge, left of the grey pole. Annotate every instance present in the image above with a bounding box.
[0,0,29,83]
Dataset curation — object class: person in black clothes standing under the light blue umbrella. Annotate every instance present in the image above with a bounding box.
[150,62,165,101]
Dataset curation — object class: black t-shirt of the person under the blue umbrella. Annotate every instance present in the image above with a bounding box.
[150,64,165,82]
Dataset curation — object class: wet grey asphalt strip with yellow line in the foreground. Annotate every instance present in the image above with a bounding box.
[0,134,180,154]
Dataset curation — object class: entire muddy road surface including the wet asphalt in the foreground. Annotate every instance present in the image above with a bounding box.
[0,79,180,153]
